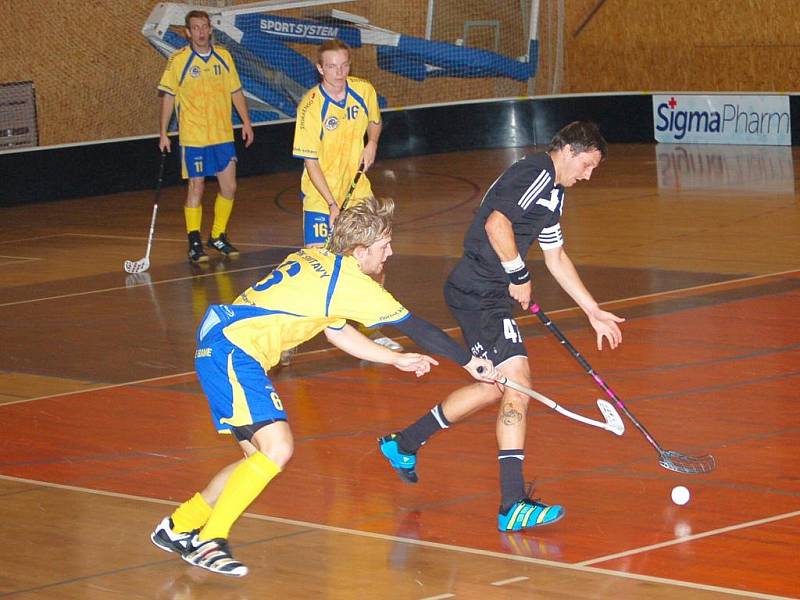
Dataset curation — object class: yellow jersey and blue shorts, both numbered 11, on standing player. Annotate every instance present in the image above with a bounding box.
[158,45,242,177]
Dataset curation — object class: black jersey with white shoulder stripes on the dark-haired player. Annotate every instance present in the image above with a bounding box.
[449,153,564,293]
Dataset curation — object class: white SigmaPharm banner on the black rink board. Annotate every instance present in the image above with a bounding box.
[653,94,792,146]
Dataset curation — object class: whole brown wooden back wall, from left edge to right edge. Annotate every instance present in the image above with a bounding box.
[0,0,800,145]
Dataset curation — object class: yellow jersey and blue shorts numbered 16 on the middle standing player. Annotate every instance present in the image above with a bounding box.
[292,77,381,243]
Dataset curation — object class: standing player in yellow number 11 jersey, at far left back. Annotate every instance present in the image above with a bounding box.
[158,10,253,262]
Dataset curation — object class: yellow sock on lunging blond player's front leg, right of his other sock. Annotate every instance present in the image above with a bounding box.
[200,452,281,541]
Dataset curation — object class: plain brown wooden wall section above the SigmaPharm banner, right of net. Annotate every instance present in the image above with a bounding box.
[564,0,800,93]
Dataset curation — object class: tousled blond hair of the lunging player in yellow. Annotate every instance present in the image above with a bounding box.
[328,196,394,256]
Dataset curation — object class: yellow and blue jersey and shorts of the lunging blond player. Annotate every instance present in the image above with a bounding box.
[195,248,409,432]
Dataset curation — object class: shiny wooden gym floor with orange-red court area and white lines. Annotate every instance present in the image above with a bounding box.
[0,145,800,600]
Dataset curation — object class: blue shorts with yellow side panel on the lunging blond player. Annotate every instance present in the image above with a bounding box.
[194,308,286,433]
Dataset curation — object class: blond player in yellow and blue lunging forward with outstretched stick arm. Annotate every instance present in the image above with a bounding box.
[151,198,496,577]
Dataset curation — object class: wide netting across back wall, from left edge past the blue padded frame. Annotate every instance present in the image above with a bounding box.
[0,0,564,152]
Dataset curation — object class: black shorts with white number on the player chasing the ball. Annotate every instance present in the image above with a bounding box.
[444,280,528,366]
